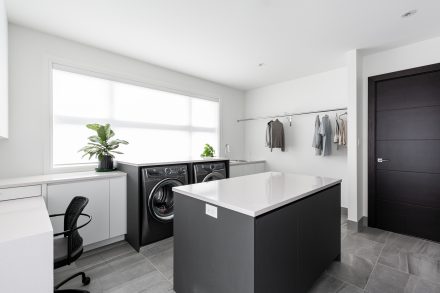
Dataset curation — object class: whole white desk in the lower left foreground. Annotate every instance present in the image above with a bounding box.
[0,196,53,293]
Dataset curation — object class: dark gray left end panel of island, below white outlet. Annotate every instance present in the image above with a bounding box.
[174,193,254,293]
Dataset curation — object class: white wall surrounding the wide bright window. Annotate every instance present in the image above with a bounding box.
[0,24,244,178]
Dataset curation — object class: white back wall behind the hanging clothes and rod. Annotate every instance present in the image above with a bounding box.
[242,67,348,207]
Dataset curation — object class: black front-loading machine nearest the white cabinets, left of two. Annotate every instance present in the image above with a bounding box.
[141,165,189,246]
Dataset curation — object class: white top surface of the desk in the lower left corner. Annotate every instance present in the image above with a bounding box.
[0,196,53,243]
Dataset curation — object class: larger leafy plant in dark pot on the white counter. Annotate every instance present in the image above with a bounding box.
[79,123,128,172]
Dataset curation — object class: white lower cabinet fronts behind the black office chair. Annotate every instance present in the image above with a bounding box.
[47,177,127,245]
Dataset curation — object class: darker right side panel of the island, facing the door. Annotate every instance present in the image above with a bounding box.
[254,185,341,293]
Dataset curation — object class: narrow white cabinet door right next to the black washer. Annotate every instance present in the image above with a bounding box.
[110,177,127,238]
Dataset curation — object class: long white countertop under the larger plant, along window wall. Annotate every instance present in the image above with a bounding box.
[0,171,127,188]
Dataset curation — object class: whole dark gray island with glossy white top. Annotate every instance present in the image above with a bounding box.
[173,172,341,293]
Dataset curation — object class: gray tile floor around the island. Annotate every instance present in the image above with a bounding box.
[55,215,440,293]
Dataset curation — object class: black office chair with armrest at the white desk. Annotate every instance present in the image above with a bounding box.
[50,196,92,293]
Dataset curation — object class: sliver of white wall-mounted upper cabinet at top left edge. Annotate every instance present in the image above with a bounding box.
[0,0,8,140]
